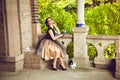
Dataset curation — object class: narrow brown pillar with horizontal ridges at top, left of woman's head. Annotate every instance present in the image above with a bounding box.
[30,0,41,46]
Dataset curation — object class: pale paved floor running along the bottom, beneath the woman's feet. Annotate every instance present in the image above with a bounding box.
[0,68,118,80]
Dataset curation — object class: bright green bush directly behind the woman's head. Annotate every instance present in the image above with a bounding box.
[39,2,75,34]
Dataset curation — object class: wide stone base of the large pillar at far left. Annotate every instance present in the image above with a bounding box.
[0,54,24,72]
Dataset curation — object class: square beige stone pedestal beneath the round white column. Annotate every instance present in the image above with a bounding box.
[73,27,89,68]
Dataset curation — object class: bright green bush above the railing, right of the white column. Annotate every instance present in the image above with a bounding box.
[85,3,120,35]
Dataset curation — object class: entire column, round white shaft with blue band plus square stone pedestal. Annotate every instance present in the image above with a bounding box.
[73,0,88,68]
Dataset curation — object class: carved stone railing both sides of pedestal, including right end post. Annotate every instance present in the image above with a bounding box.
[59,35,120,78]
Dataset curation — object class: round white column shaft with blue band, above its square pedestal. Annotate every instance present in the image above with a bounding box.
[76,0,85,27]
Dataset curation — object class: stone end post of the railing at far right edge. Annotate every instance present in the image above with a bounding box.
[115,37,120,78]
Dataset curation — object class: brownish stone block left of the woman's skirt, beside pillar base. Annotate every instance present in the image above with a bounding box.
[24,51,48,70]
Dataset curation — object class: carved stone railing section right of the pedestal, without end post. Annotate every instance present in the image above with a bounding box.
[87,35,118,68]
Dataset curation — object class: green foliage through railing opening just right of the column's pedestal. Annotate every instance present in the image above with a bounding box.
[87,43,97,61]
